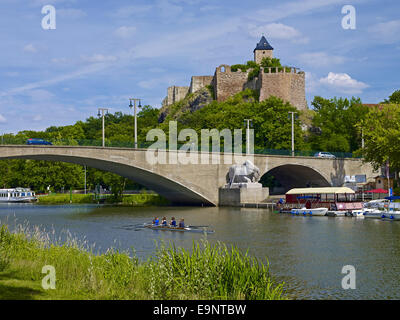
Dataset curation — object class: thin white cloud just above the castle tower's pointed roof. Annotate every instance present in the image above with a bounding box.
[249,23,308,43]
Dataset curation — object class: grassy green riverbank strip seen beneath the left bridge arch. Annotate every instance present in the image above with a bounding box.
[38,193,169,207]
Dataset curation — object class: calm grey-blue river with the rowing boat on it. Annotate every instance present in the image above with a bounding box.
[0,204,400,299]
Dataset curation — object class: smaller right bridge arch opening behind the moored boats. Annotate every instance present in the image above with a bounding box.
[260,164,331,195]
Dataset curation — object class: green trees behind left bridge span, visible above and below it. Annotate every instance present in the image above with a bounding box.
[0,105,159,192]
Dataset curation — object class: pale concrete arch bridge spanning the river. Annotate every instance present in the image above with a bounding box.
[0,145,377,206]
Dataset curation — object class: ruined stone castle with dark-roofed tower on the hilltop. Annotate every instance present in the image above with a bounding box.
[162,36,307,110]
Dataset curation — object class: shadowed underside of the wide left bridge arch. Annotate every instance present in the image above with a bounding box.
[0,147,216,206]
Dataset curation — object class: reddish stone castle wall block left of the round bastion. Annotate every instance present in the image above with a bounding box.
[213,65,248,101]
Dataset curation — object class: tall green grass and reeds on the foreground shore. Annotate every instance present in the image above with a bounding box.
[0,224,287,300]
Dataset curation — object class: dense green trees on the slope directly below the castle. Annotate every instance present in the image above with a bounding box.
[178,89,304,149]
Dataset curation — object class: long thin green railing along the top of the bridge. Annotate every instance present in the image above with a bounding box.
[0,137,361,158]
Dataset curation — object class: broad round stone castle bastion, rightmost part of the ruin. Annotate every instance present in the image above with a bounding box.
[258,68,307,110]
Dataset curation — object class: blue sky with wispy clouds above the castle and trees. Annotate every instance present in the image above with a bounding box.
[0,0,400,133]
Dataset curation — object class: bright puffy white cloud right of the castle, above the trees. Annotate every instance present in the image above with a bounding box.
[319,72,369,94]
